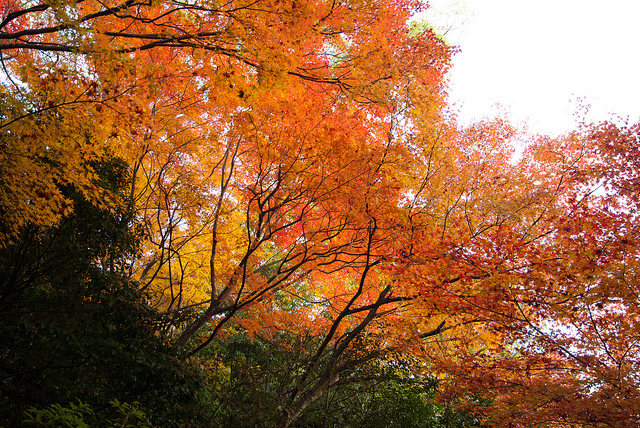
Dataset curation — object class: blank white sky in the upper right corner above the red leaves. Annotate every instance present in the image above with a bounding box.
[425,0,640,134]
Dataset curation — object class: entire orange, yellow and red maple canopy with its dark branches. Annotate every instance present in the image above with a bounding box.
[0,0,639,427]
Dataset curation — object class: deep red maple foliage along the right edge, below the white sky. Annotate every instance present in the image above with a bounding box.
[404,118,639,427]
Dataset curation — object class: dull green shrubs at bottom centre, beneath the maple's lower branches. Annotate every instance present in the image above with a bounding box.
[200,333,479,428]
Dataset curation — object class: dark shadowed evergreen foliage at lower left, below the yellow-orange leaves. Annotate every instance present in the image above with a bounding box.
[0,159,201,426]
